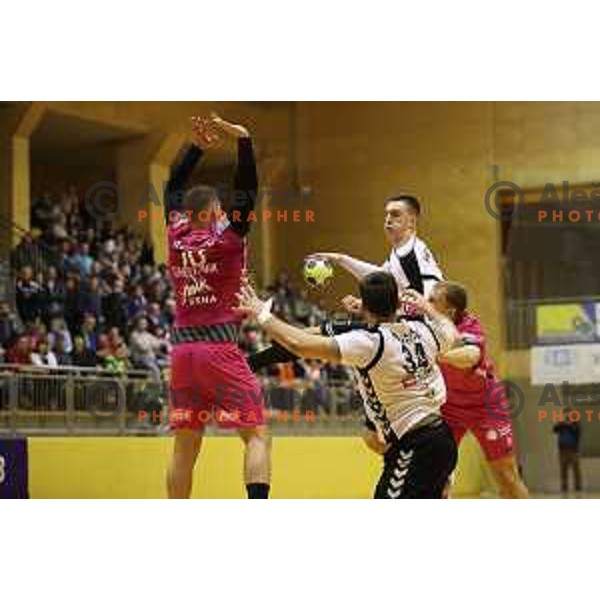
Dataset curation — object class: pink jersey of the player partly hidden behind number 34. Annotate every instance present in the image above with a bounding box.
[440,313,497,407]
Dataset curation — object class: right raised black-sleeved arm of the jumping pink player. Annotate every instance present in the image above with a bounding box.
[211,114,258,236]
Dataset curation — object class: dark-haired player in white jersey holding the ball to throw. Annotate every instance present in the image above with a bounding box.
[313,194,444,304]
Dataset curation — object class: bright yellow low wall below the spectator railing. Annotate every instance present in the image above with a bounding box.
[29,437,486,498]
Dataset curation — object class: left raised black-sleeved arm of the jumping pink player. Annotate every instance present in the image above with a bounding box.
[164,117,219,225]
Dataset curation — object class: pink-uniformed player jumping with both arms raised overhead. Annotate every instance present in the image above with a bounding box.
[165,116,270,498]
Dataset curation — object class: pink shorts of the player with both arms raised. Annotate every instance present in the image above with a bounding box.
[169,342,265,429]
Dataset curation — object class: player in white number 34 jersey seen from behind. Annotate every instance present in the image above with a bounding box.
[240,271,458,499]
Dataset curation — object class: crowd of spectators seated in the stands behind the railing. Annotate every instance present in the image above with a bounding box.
[0,186,356,414]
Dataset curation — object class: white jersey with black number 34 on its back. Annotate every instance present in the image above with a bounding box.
[334,318,455,442]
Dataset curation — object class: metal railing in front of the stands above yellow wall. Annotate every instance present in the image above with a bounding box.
[0,365,362,437]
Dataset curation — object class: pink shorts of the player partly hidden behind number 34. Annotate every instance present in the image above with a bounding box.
[442,404,514,462]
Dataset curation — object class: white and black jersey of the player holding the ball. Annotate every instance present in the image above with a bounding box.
[382,236,444,297]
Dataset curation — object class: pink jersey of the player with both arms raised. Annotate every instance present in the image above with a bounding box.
[168,222,246,327]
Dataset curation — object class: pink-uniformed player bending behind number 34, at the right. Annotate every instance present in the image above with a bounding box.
[429,281,529,498]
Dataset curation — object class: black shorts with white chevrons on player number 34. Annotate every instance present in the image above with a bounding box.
[375,419,458,500]
